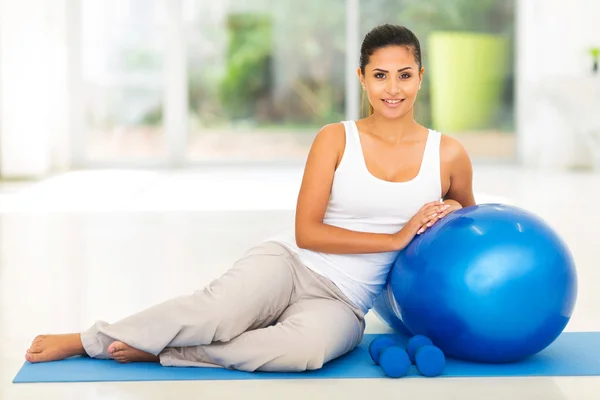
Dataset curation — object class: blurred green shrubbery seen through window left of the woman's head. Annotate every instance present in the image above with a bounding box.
[188,0,346,127]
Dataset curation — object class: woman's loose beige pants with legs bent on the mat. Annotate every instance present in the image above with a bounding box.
[81,242,365,371]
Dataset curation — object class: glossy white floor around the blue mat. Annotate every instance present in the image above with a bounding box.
[0,166,600,400]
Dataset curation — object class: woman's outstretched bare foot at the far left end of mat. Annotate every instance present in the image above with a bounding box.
[25,333,86,363]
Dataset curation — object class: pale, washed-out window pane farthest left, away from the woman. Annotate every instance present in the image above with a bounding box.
[81,0,167,161]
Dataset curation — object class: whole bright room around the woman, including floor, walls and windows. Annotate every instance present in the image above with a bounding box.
[0,0,600,400]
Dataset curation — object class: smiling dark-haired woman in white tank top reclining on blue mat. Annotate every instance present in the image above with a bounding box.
[25,25,474,371]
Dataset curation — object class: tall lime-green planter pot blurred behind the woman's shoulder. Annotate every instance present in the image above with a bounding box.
[429,32,509,133]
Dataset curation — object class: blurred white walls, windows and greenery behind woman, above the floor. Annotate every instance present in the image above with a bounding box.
[0,0,600,180]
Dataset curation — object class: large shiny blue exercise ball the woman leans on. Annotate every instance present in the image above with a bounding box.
[376,204,577,363]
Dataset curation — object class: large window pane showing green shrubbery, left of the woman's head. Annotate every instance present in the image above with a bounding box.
[184,0,346,161]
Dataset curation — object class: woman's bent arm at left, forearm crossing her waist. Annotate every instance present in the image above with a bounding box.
[296,124,424,254]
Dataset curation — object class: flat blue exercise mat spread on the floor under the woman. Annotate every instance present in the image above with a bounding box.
[13,332,600,383]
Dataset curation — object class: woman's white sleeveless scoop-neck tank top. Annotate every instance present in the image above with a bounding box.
[270,121,442,313]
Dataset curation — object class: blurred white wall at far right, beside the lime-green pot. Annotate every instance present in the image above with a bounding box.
[516,0,600,169]
